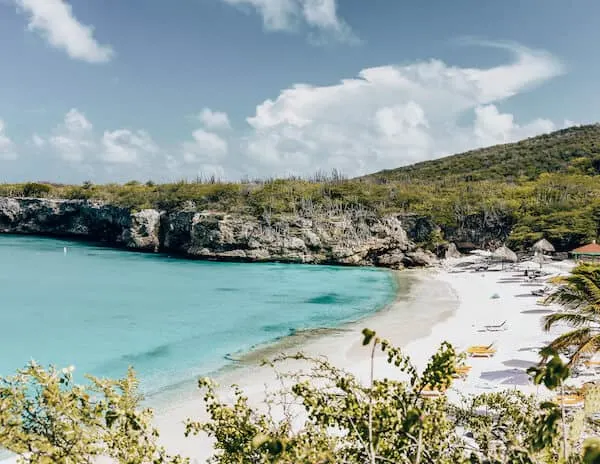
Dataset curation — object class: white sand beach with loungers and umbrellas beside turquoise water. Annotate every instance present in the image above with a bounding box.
[156,262,573,463]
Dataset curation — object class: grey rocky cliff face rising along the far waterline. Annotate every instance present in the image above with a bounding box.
[0,198,436,268]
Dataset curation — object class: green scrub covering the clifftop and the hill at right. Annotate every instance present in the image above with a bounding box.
[0,125,600,250]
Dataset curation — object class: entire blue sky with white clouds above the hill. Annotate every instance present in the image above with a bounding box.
[0,0,600,183]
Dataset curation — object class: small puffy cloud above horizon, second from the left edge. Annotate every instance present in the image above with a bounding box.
[48,108,96,162]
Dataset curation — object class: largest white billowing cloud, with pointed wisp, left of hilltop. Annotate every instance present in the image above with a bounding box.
[238,47,563,175]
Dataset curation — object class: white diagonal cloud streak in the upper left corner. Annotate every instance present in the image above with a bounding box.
[16,0,114,63]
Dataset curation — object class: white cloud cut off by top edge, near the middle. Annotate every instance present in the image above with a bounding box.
[222,0,356,42]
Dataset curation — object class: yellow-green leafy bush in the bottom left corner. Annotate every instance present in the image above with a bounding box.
[0,362,187,464]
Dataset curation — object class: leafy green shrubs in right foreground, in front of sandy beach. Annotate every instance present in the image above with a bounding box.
[187,330,599,464]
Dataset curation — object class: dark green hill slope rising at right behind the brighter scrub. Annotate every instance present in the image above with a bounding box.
[366,124,600,182]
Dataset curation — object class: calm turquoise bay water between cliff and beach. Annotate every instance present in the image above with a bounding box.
[0,236,394,394]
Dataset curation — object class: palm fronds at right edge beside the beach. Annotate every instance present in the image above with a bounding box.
[544,264,600,366]
